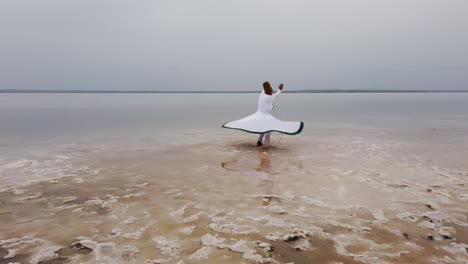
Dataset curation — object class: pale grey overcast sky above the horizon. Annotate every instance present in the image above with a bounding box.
[0,0,468,90]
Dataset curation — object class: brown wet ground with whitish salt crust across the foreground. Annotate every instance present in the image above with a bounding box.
[0,131,468,263]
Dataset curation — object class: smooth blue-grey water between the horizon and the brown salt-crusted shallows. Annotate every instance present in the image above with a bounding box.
[0,93,468,141]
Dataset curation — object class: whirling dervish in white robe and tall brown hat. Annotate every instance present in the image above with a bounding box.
[223,81,304,146]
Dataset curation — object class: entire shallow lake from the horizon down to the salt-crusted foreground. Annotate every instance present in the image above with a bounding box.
[0,94,468,263]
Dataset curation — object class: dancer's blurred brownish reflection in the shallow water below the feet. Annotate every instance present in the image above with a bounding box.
[221,154,280,206]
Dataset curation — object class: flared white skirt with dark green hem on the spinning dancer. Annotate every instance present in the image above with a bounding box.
[223,111,304,135]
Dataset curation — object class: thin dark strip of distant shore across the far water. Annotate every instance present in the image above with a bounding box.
[0,89,468,94]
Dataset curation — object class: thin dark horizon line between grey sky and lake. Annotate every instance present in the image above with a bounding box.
[0,89,468,94]
